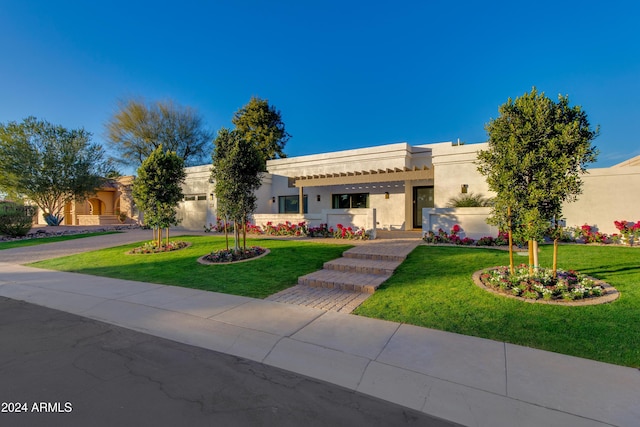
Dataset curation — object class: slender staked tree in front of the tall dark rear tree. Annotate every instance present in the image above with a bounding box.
[211,128,264,252]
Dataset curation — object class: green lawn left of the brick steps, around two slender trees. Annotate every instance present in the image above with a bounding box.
[31,236,351,298]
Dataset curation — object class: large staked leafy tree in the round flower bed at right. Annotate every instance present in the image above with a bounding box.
[477,87,598,278]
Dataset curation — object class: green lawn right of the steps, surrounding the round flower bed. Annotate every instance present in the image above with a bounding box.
[356,245,640,367]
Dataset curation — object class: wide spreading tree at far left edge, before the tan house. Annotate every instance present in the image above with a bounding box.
[0,117,113,225]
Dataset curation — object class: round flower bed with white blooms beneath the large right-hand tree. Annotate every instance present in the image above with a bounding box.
[479,264,607,301]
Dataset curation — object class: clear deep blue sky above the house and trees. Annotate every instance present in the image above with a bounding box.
[0,0,640,167]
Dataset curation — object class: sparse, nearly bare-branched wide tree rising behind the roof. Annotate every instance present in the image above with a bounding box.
[106,99,212,167]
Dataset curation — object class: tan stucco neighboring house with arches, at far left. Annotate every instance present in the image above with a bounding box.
[37,176,137,225]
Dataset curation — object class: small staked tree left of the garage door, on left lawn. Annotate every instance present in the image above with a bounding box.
[132,146,186,247]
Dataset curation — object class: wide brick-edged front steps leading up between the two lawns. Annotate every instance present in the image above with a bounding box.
[298,240,420,294]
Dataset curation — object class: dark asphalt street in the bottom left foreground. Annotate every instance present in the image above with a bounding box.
[0,297,457,427]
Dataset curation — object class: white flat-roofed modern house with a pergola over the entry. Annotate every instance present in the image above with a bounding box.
[178,142,640,238]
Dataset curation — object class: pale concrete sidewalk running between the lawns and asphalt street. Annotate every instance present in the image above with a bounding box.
[0,235,640,427]
